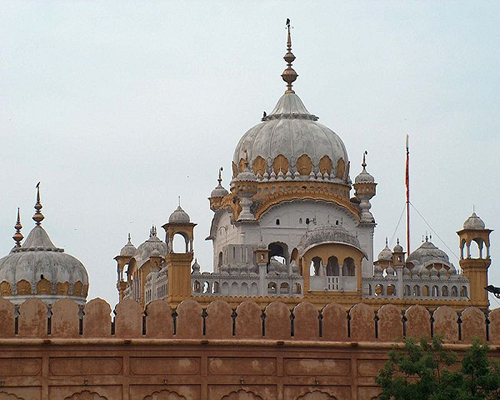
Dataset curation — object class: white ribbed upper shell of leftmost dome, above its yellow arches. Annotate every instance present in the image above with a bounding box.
[0,225,89,298]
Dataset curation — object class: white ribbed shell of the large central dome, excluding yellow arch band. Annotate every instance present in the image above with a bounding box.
[233,93,348,180]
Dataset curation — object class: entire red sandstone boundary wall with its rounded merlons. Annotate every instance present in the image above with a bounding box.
[0,298,500,400]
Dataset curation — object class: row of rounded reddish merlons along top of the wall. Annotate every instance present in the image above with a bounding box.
[0,298,500,345]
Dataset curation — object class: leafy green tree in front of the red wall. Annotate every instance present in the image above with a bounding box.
[376,337,500,400]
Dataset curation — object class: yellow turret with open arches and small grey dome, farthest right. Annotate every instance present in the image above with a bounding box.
[457,212,493,308]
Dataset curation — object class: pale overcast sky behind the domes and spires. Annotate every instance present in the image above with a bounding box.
[0,1,500,307]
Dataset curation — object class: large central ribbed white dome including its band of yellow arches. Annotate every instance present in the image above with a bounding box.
[233,93,349,183]
